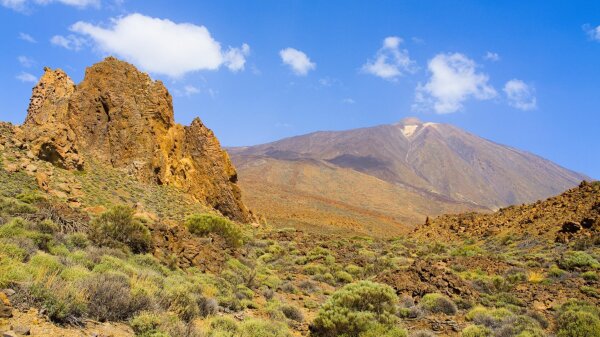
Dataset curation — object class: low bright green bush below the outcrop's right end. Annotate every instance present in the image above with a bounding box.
[185,214,243,247]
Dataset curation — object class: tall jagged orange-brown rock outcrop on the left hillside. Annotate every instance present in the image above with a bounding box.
[23,57,251,222]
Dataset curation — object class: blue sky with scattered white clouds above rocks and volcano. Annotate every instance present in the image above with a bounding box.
[0,0,600,178]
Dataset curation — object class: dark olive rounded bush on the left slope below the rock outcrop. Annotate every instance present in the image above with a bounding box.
[89,206,152,254]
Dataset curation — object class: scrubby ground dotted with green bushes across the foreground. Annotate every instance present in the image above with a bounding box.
[0,146,600,337]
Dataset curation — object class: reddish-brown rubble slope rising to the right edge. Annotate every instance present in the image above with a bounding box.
[412,178,600,245]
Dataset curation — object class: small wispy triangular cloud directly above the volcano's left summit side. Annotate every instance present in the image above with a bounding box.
[362,36,418,80]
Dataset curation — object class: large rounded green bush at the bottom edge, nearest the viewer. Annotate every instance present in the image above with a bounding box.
[310,281,398,337]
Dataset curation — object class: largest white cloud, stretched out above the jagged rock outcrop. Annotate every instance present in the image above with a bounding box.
[71,13,250,77]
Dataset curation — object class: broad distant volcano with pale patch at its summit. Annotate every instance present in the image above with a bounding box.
[228,118,587,233]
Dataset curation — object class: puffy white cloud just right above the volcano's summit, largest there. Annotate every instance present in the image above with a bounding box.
[413,53,497,114]
